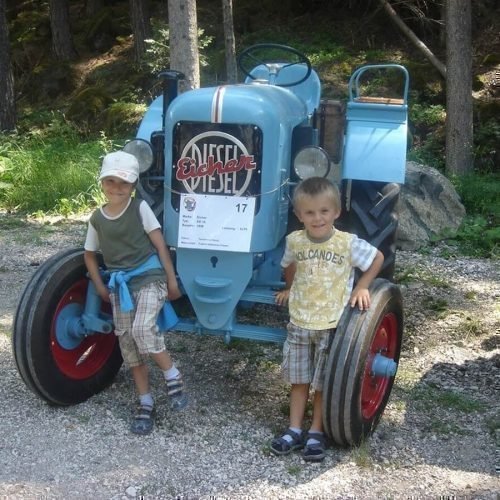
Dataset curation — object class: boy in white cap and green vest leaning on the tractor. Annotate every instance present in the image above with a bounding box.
[84,151,187,435]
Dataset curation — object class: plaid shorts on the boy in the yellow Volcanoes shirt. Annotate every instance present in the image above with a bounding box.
[282,323,332,391]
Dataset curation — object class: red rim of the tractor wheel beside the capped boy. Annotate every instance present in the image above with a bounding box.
[50,279,116,380]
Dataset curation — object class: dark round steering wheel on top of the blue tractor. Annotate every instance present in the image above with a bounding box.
[238,43,312,87]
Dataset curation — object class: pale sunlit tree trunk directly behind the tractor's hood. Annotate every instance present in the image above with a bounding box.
[168,0,200,92]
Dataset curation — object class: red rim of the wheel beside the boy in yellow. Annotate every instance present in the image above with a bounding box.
[361,313,398,420]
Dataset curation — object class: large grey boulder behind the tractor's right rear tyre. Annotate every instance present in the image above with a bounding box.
[396,161,465,250]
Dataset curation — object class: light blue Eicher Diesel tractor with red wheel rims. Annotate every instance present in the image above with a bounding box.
[13,44,408,446]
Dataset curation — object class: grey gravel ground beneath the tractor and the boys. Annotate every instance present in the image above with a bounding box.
[0,214,500,499]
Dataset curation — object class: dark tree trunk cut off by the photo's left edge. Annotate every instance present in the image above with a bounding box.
[0,0,16,132]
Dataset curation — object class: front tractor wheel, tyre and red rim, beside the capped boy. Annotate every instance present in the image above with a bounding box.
[12,248,122,406]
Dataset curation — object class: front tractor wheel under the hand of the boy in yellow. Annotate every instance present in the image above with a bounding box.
[323,279,403,446]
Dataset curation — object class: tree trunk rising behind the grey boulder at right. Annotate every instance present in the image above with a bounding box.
[446,0,474,175]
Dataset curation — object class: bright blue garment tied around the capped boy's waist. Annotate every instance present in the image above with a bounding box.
[108,254,179,331]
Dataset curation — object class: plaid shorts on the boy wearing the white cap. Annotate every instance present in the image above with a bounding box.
[110,281,167,368]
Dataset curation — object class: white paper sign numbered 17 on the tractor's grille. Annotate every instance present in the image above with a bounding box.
[177,193,255,252]
